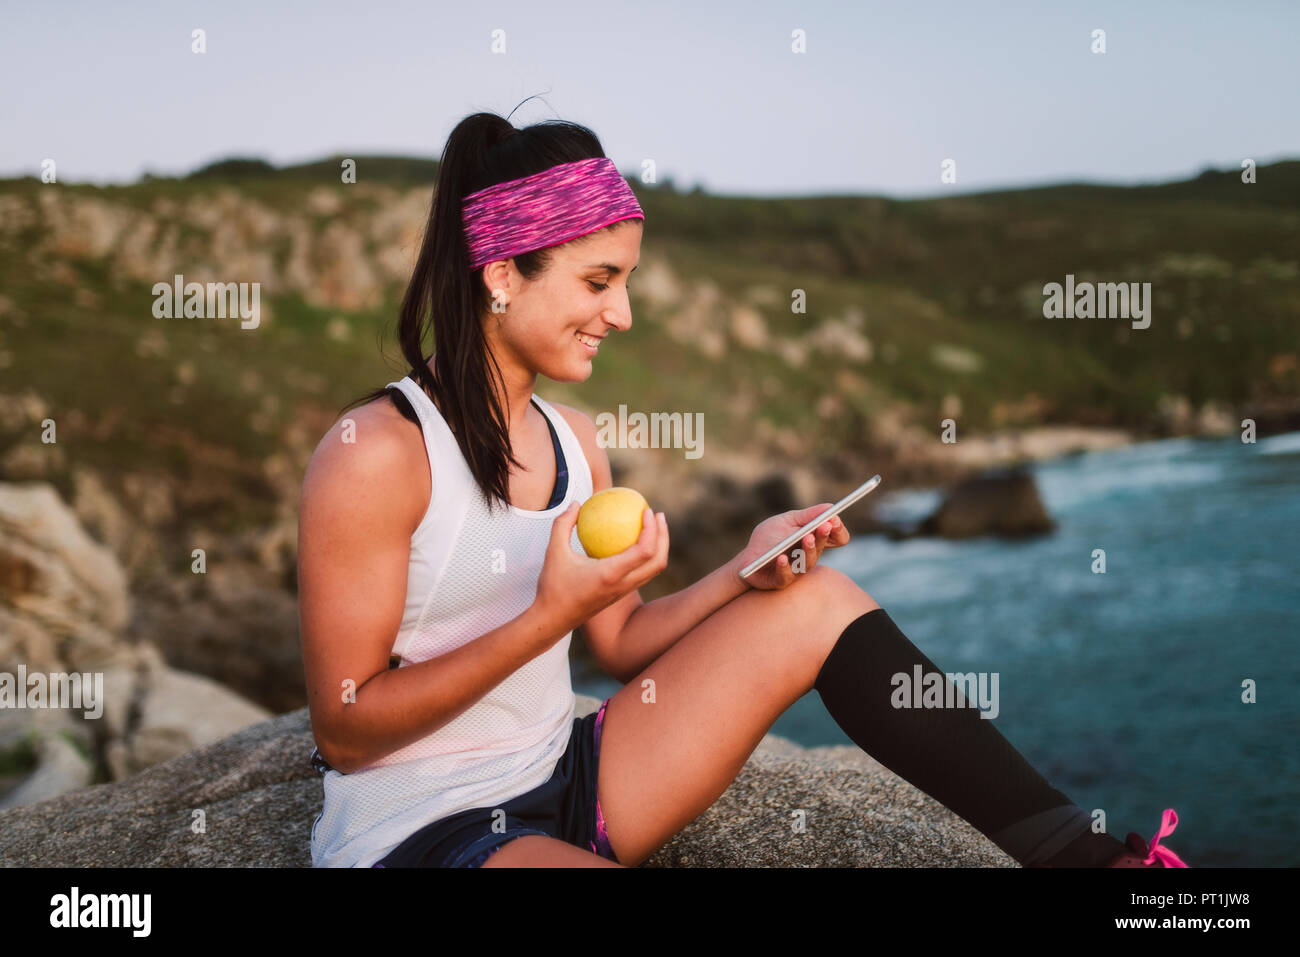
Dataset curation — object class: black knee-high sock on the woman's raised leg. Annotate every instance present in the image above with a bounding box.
[814,609,1123,867]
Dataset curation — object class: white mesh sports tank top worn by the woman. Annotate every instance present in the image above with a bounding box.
[311,376,592,867]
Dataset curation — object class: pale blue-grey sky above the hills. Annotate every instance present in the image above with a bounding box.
[0,0,1300,196]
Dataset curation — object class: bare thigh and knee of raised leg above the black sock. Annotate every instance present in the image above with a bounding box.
[595,566,879,865]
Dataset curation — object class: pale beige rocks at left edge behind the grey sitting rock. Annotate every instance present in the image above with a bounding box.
[0,482,269,807]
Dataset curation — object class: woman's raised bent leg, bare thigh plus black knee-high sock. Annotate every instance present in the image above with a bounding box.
[598,566,1123,866]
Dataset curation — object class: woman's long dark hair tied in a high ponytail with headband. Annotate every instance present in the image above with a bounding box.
[343,107,605,507]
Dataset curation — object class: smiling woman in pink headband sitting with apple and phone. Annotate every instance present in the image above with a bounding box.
[299,106,1177,867]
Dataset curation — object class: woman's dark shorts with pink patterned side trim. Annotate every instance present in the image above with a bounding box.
[374,698,619,867]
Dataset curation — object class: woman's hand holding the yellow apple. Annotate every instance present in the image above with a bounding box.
[534,502,668,636]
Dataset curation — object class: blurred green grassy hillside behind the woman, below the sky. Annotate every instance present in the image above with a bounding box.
[0,159,1300,538]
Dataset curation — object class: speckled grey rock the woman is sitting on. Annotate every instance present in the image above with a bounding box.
[0,696,1015,867]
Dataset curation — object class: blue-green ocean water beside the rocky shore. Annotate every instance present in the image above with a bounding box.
[575,433,1300,866]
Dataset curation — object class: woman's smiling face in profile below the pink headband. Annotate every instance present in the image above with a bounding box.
[484,220,644,382]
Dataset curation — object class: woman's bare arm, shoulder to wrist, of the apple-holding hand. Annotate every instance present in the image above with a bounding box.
[298,403,566,774]
